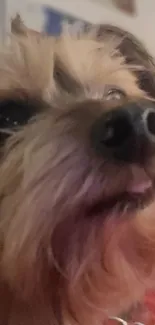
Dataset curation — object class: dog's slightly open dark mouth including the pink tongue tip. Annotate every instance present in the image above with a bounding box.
[90,166,155,214]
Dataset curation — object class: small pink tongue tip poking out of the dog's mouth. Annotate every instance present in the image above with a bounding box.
[127,165,152,194]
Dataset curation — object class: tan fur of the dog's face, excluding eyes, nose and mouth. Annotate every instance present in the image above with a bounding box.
[0,18,155,325]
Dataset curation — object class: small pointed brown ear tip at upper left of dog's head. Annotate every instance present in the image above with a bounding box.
[11,14,43,36]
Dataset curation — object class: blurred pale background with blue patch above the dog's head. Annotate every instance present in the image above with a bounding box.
[0,0,155,54]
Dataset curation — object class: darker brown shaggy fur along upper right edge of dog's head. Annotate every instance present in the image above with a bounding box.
[94,24,155,97]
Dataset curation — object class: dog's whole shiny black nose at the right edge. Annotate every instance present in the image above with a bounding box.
[91,101,155,162]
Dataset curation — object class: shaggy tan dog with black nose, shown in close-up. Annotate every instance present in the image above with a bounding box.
[0,17,155,325]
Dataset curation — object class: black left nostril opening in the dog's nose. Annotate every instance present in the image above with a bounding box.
[100,113,132,148]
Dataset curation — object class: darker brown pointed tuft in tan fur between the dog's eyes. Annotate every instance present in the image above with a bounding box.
[53,58,82,94]
